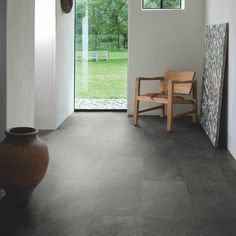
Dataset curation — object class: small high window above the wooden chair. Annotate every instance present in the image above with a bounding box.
[142,0,182,9]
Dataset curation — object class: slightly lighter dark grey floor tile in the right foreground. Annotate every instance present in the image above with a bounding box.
[143,181,194,220]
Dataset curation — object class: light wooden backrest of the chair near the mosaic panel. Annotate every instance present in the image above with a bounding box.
[160,70,195,95]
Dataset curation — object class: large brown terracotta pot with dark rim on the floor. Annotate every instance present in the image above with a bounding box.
[0,127,49,201]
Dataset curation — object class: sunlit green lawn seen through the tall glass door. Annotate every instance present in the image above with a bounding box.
[75,50,127,99]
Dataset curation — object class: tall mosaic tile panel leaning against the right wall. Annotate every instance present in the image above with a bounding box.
[200,24,228,147]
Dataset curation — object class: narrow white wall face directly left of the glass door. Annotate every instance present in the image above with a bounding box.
[55,0,75,127]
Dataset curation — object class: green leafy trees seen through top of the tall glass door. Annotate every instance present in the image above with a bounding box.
[76,0,128,49]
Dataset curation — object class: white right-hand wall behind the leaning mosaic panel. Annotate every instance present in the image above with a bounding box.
[206,0,236,157]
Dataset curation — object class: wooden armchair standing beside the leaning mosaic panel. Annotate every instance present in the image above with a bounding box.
[134,70,197,132]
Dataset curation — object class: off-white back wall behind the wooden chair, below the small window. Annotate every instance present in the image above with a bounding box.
[128,0,205,114]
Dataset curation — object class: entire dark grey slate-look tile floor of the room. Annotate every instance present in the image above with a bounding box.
[0,113,236,236]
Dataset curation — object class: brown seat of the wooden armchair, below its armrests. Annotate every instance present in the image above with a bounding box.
[138,93,195,104]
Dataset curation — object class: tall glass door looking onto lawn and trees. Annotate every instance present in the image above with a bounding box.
[75,0,128,110]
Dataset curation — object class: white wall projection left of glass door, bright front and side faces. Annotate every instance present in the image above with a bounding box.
[35,0,74,130]
